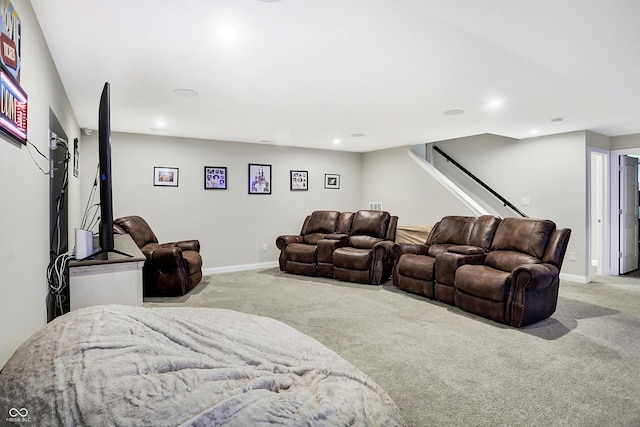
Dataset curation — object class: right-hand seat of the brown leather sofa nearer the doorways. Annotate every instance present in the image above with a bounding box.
[454,218,571,327]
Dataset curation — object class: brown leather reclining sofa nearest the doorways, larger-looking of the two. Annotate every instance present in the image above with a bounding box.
[393,216,571,327]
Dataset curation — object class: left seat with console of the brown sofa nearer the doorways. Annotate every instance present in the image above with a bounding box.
[393,215,500,304]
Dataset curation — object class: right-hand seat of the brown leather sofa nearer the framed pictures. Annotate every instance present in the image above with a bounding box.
[333,210,398,285]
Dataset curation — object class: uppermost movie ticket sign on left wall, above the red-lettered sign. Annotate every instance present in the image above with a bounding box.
[0,0,22,83]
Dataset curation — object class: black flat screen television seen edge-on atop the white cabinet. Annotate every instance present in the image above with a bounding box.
[88,82,131,259]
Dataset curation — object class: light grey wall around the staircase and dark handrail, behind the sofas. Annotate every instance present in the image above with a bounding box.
[363,132,590,280]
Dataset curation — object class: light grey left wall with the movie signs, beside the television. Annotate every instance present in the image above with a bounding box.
[0,0,78,366]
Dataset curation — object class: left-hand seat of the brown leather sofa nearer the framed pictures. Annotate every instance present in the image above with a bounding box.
[276,210,350,276]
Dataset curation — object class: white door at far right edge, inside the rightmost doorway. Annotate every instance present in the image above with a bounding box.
[620,156,638,274]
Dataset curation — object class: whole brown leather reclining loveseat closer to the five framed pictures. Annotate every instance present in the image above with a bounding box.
[276,210,398,285]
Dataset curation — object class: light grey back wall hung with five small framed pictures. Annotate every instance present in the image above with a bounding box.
[80,132,368,272]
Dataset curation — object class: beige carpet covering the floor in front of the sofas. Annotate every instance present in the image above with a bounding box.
[145,268,640,427]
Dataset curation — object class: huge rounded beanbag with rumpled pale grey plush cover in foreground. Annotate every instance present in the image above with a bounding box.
[0,306,403,427]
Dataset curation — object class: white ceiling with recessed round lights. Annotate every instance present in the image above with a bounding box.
[31,0,640,152]
